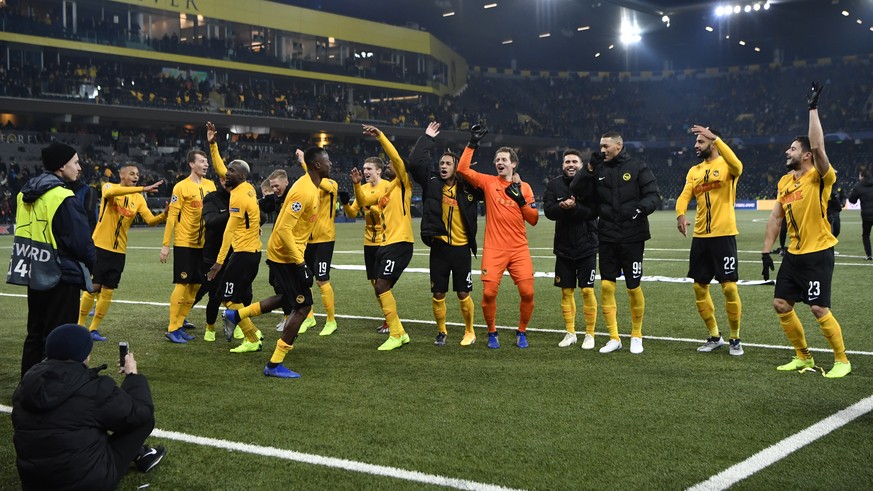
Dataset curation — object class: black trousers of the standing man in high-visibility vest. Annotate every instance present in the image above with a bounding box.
[21,282,80,377]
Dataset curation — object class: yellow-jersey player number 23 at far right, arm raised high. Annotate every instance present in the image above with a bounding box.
[761,82,852,378]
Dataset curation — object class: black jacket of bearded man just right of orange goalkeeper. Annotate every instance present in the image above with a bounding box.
[543,173,598,259]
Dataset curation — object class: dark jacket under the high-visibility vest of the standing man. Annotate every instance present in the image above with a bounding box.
[21,172,97,289]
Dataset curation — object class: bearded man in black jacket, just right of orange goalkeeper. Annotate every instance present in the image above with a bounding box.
[543,148,598,349]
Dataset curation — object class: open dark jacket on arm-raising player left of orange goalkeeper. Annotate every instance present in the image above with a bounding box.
[407,135,485,256]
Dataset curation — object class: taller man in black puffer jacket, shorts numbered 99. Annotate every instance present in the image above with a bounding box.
[570,132,661,354]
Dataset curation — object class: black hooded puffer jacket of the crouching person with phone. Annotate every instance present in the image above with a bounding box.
[12,360,154,490]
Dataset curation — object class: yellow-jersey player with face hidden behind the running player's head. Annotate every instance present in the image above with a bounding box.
[297,150,339,336]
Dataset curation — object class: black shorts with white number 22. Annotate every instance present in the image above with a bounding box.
[688,235,740,284]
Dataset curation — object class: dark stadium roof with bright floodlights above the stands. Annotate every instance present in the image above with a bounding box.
[280,0,873,71]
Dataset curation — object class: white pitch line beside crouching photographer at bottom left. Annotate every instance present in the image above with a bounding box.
[0,404,513,491]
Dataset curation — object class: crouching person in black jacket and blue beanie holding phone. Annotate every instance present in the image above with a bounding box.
[12,324,166,490]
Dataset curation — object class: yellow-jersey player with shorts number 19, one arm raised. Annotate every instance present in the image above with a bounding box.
[160,127,227,344]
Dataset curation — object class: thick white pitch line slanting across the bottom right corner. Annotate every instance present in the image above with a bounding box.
[688,396,873,491]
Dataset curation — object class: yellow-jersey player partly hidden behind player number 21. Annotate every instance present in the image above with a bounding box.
[339,157,390,334]
